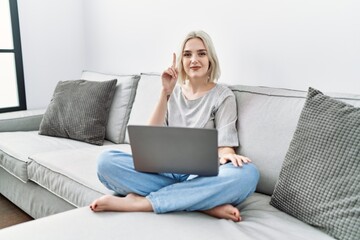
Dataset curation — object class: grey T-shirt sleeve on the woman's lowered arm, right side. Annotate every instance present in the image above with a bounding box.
[215,94,239,147]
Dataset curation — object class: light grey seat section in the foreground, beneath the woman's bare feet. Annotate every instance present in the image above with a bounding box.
[0,194,334,240]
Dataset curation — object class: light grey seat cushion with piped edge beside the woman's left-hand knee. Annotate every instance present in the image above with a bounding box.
[28,144,131,207]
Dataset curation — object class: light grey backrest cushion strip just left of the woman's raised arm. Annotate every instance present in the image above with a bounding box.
[124,73,162,143]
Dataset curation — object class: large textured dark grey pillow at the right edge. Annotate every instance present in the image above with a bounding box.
[270,88,360,239]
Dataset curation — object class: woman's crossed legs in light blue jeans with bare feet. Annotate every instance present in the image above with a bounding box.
[90,151,259,221]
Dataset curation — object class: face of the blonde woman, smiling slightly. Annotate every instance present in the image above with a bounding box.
[182,38,209,81]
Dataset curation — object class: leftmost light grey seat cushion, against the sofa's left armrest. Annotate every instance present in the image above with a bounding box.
[0,131,112,182]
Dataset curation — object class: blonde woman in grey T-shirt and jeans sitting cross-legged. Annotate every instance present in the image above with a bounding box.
[90,31,259,222]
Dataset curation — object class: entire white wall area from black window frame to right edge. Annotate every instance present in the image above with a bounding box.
[18,0,360,109]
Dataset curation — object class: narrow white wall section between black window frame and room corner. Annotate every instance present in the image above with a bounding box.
[18,0,85,109]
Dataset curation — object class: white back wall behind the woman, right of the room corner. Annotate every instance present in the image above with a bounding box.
[85,0,360,93]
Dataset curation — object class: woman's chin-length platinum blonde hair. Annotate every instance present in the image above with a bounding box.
[177,31,221,84]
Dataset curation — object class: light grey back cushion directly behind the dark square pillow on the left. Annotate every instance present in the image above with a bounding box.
[81,71,140,143]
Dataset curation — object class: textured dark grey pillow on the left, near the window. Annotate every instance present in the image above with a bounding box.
[39,79,117,145]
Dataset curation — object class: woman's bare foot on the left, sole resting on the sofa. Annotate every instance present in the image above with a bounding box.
[90,193,153,212]
